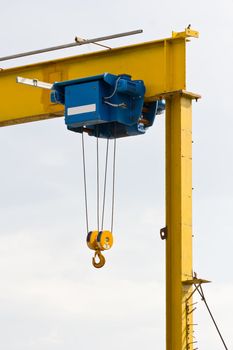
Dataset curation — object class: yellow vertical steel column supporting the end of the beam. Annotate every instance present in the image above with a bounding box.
[166,93,193,350]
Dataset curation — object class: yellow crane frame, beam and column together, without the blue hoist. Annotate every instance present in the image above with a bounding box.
[0,28,206,350]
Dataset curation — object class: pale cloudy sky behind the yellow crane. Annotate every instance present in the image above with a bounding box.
[0,0,233,350]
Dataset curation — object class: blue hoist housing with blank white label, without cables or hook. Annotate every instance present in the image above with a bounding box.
[51,73,164,138]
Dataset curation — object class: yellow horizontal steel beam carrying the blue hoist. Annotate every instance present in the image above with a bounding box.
[0,32,198,126]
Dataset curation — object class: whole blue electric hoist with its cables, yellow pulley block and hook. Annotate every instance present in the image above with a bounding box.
[17,73,165,268]
